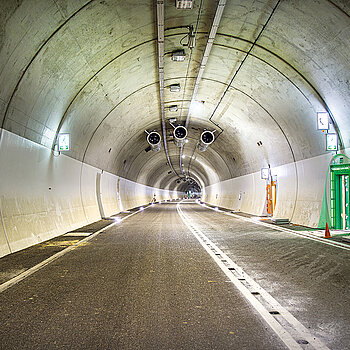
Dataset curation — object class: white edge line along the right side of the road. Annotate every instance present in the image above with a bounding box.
[197,203,350,251]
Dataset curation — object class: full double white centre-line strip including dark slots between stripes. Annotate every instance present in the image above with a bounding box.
[177,202,329,350]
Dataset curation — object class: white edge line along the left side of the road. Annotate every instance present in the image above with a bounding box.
[0,206,144,293]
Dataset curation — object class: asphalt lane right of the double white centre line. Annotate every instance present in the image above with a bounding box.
[182,203,350,349]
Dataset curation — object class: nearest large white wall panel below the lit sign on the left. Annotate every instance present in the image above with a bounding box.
[0,131,86,251]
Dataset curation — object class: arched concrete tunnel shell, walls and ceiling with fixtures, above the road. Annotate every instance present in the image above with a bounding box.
[0,0,350,349]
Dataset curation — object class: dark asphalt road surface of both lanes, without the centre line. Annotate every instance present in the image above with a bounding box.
[0,202,350,350]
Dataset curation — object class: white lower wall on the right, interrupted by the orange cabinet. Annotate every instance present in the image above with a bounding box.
[203,149,350,227]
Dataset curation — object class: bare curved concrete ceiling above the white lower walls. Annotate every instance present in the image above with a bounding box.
[0,0,350,190]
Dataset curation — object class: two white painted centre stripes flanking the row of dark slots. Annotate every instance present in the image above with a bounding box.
[177,202,329,350]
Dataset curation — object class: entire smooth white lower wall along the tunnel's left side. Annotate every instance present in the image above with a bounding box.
[0,130,178,256]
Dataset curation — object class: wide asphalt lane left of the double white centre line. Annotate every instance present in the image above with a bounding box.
[0,203,284,349]
